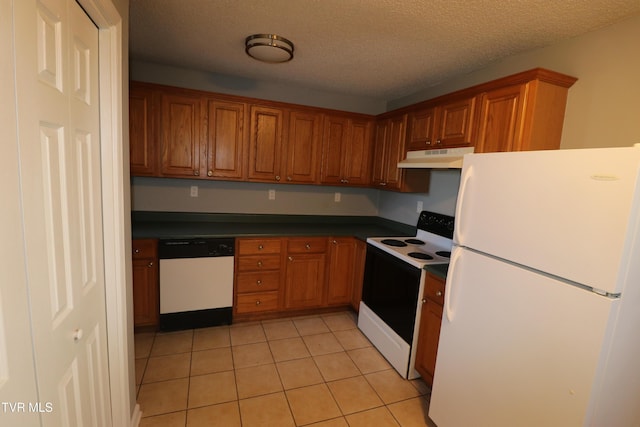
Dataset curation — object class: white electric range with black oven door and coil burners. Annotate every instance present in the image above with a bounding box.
[358,211,454,379]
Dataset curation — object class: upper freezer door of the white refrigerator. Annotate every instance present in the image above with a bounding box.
[454,147,640,293]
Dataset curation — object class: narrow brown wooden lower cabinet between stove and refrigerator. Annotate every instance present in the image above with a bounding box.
[416,273,445,386]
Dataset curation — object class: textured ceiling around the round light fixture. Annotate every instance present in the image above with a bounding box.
[130,0,640,100]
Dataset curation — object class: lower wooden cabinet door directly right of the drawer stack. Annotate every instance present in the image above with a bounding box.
[285,253,325,309]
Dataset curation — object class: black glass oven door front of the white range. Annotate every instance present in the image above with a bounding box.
[362,245,422,345]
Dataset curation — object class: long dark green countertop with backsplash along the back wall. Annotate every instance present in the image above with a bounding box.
[131,211,416,240]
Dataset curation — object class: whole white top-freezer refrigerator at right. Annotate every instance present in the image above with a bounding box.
[429,145,640,427]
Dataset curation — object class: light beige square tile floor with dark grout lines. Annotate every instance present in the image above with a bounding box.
[135,312,433,427]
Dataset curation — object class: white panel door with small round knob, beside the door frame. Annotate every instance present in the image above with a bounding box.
[14,0,111,427]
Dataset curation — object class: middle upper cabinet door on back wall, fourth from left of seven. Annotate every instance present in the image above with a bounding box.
[248,105,284,181]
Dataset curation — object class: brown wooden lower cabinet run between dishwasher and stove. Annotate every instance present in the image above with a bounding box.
[234,237,366,321]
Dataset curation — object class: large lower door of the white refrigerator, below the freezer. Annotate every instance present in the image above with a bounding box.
[429,248,618,427]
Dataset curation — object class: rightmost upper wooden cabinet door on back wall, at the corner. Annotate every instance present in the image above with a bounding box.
[342,120,371,185]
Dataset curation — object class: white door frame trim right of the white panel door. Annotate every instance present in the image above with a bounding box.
[77,0,136,426]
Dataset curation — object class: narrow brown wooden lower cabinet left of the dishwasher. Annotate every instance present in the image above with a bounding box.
[132,239,160,327]
